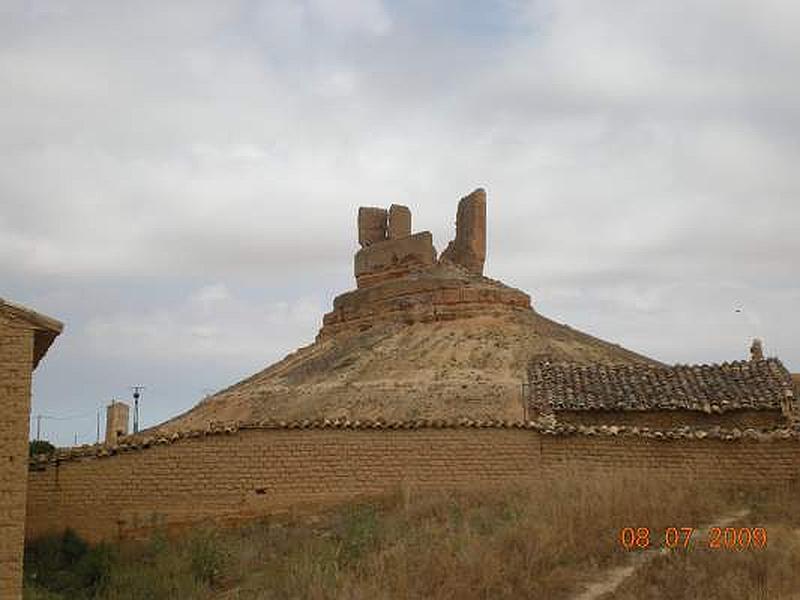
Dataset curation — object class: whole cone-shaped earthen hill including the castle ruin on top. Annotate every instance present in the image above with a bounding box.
[156,190,655,429]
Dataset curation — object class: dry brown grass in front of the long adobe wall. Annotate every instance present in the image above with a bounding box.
[25,473,800,600]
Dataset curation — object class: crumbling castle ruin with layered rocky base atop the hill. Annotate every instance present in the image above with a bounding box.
[317,188,531,339]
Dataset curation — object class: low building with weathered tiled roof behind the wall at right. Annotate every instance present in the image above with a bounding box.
[526,358,794,428]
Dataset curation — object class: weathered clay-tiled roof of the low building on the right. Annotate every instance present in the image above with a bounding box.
[528,358,792,413]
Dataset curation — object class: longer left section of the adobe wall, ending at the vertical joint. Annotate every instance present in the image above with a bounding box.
[27,429,538,541]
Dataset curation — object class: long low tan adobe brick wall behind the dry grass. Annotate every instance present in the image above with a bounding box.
[26,427,800,541]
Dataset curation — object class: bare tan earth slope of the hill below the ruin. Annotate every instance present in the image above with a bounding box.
[159,311,654,429]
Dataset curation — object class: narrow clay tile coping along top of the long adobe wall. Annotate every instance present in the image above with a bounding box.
[30,419,800,469]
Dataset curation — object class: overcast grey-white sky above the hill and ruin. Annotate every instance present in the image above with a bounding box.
[0,0,800,444]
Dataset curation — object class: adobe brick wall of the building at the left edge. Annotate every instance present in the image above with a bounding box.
[0,311,34,600]
